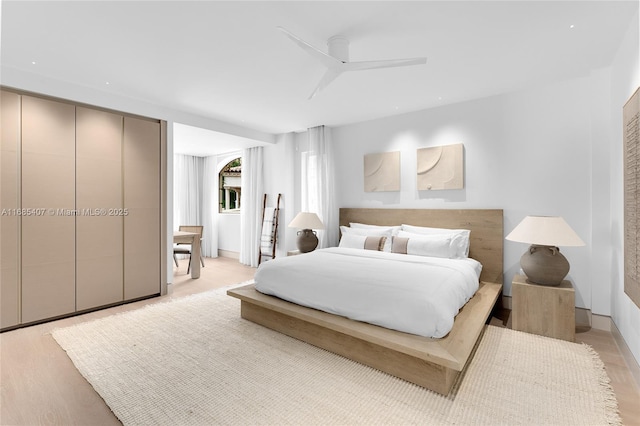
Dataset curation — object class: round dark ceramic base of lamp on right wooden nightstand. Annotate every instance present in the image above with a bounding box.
[520,244,569,286]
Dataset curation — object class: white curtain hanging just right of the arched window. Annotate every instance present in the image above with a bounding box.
[240,146,264,267]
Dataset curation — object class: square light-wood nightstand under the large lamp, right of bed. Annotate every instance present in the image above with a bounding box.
[511,275,576,342]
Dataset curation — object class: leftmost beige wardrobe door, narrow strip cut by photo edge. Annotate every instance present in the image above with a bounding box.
[0,91,20,328]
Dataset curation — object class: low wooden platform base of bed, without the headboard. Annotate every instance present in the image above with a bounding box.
[227,282,502,395]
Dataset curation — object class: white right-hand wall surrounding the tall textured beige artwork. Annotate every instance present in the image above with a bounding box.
[608,6,640,363]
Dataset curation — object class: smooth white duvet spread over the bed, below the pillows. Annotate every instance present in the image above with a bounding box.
[255,247,482,338]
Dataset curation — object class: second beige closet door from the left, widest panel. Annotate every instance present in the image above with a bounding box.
[21,96,76,323]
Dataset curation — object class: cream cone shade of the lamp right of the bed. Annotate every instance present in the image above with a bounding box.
[506,216,584,247]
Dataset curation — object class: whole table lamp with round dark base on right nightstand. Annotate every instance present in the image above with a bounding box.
[506,216,584,286]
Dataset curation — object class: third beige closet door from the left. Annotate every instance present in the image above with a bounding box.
[76,107,124,311]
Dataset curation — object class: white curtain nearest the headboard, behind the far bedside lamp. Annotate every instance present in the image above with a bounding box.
[301,126,338,248]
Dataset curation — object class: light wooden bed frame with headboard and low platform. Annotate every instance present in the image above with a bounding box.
[227,208,503,395]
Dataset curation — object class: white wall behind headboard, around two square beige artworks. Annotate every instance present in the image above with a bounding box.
[332,76,608,306]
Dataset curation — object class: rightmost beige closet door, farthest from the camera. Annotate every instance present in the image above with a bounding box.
[123,117,164,300]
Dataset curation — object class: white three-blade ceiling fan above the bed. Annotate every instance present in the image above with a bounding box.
[277,27,427,99]
